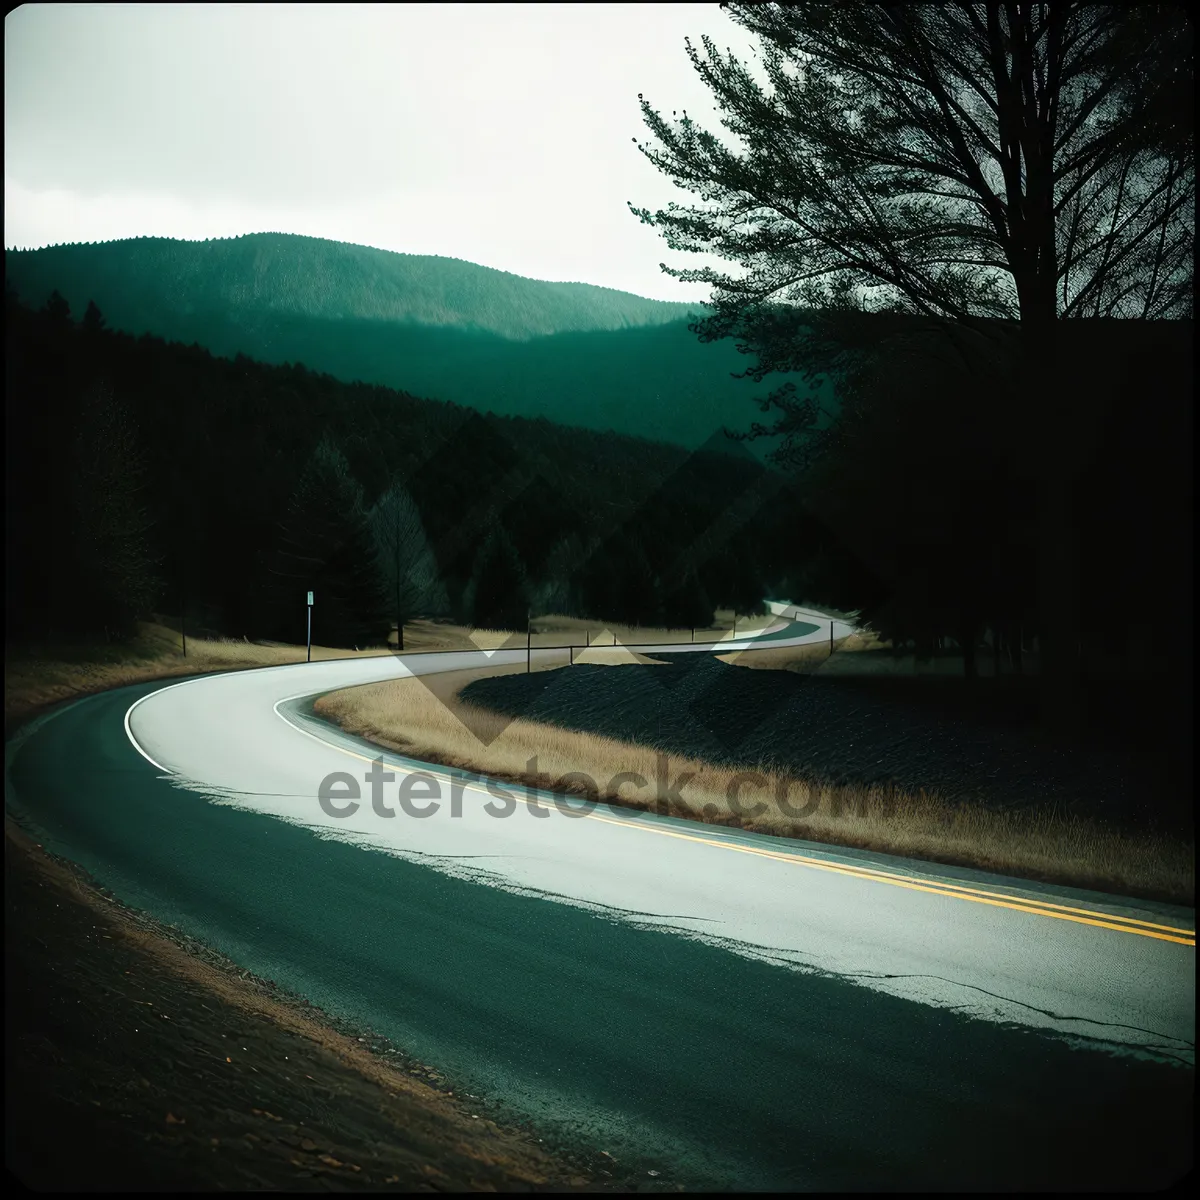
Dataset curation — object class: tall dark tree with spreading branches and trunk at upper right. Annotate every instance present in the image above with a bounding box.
[631,2,1195,728]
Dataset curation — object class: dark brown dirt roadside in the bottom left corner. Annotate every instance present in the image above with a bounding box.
[5,820,632,1192]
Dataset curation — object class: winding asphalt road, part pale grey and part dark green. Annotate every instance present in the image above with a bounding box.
[6,608,1195,1190]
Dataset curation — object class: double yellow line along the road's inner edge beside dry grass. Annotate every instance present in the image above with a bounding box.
[289,722,1195,946]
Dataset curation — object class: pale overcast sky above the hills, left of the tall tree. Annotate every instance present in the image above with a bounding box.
[4,4,754,300]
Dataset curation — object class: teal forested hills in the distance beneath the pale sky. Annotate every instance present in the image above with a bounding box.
[5,234,820,454]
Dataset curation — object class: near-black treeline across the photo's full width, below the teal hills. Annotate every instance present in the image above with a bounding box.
[6,274,1192,674]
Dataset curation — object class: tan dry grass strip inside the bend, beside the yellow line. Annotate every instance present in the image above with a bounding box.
[316,672,1194,904]
